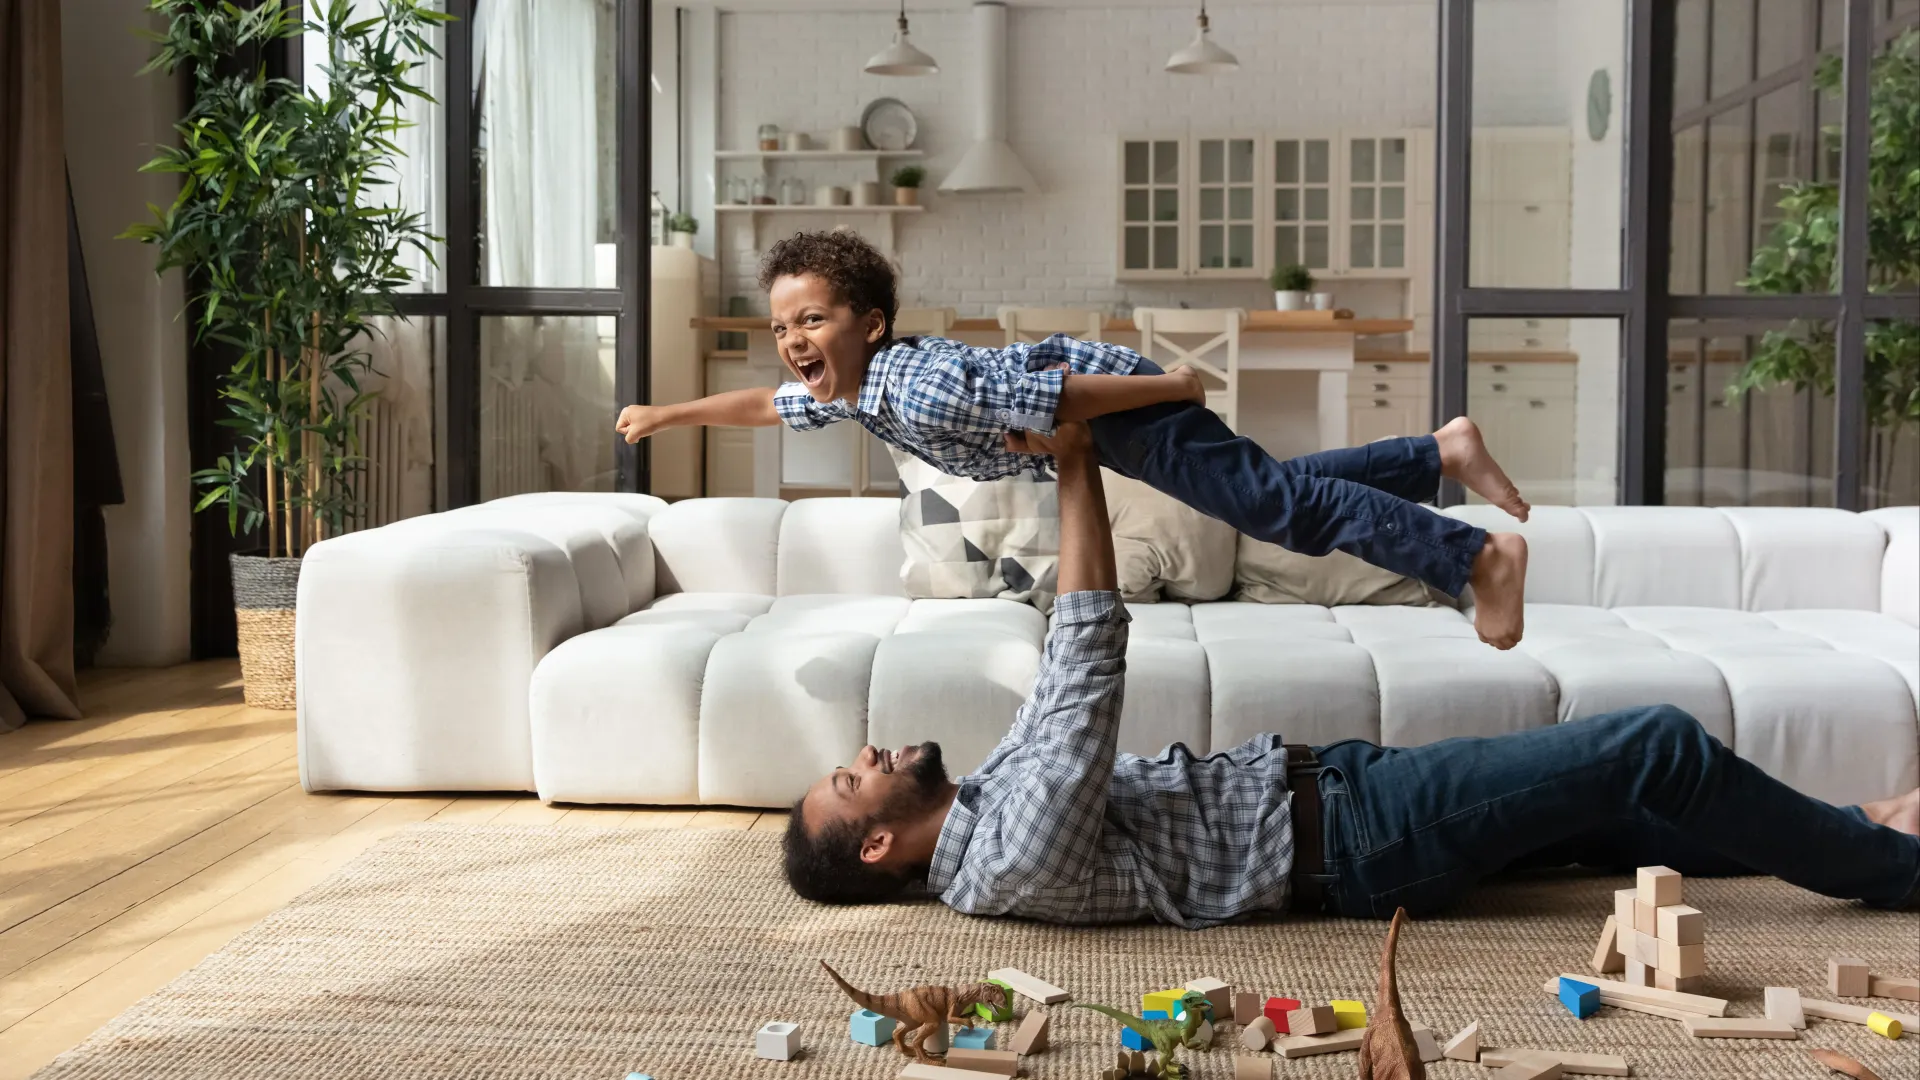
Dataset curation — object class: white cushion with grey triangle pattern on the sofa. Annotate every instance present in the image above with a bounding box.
[893,450,1060,615]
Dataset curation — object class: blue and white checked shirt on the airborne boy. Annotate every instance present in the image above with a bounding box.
[774,334,1140,480]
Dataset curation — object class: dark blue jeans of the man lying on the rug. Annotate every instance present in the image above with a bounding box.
[1317,705,1920,919]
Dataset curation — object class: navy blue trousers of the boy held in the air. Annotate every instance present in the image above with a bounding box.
[1087,359,1486,596]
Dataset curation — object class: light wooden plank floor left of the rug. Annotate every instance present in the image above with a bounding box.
[0,661,785,1080]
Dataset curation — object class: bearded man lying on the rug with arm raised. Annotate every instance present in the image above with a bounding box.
[785,425,1920,926]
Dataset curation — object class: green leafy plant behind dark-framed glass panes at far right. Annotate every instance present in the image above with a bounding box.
[1728,31,1920,492]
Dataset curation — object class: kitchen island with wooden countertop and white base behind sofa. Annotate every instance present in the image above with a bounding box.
[691,311,1413,498]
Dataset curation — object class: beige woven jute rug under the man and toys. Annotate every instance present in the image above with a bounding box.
[26,824,1920,1080]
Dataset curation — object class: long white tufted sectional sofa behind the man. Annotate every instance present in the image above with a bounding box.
[298,494,1920,807]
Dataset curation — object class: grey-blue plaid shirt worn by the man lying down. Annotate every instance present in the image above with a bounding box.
[927,592,1294,926]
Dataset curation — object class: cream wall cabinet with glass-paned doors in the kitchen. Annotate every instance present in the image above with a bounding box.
[1116,133,1425,281]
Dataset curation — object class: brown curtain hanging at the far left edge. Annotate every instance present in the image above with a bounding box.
[0,0,81,730]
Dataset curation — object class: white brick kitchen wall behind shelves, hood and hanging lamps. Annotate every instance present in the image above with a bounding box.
[691,0,1569,315]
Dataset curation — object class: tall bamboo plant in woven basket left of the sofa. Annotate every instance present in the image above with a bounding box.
[125,0,449,709]
